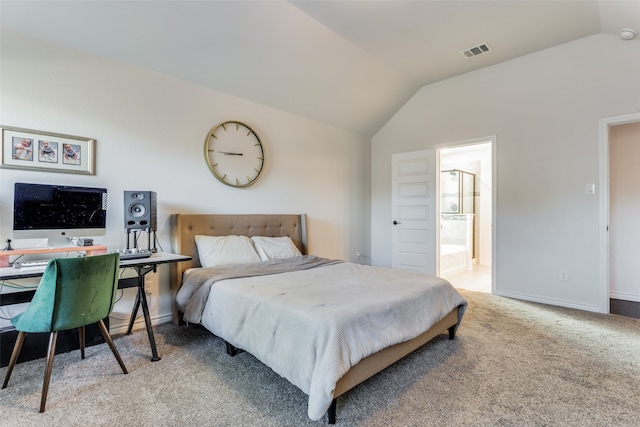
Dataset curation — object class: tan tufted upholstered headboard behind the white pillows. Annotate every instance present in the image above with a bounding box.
[171,214,307,323]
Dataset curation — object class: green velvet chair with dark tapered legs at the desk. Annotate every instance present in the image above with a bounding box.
[2,253,127,412]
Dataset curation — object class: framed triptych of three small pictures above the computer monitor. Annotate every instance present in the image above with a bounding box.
[1,126,96,175]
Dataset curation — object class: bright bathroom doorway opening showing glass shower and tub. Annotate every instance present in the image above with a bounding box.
[437,138,495,293]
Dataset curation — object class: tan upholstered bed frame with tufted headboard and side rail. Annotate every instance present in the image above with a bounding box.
[171,214,458,424]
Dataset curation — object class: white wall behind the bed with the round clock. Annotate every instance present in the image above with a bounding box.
[0,31,370,330]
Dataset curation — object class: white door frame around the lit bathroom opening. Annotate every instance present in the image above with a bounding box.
[433,135,498,294]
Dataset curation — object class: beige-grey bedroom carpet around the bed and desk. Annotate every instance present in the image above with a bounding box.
[0,290,640,426]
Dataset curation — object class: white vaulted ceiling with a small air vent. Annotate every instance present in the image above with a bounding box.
[0,0,640,135]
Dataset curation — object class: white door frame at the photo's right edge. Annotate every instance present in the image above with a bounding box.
[598,113,640,313]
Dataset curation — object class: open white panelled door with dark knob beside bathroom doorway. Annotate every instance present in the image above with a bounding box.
[391,150,438,275]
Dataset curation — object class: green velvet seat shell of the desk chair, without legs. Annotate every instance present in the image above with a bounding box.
[14,253,120,332]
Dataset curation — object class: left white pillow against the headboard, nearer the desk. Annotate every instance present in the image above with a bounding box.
[196,235,260,267]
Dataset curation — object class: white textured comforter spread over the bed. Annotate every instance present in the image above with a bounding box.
[178,263,466,420]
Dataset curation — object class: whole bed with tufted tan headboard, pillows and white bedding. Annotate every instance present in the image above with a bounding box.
[171,214,466,424]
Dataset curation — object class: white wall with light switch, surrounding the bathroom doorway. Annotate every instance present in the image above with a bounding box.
[371,35,640,311]
